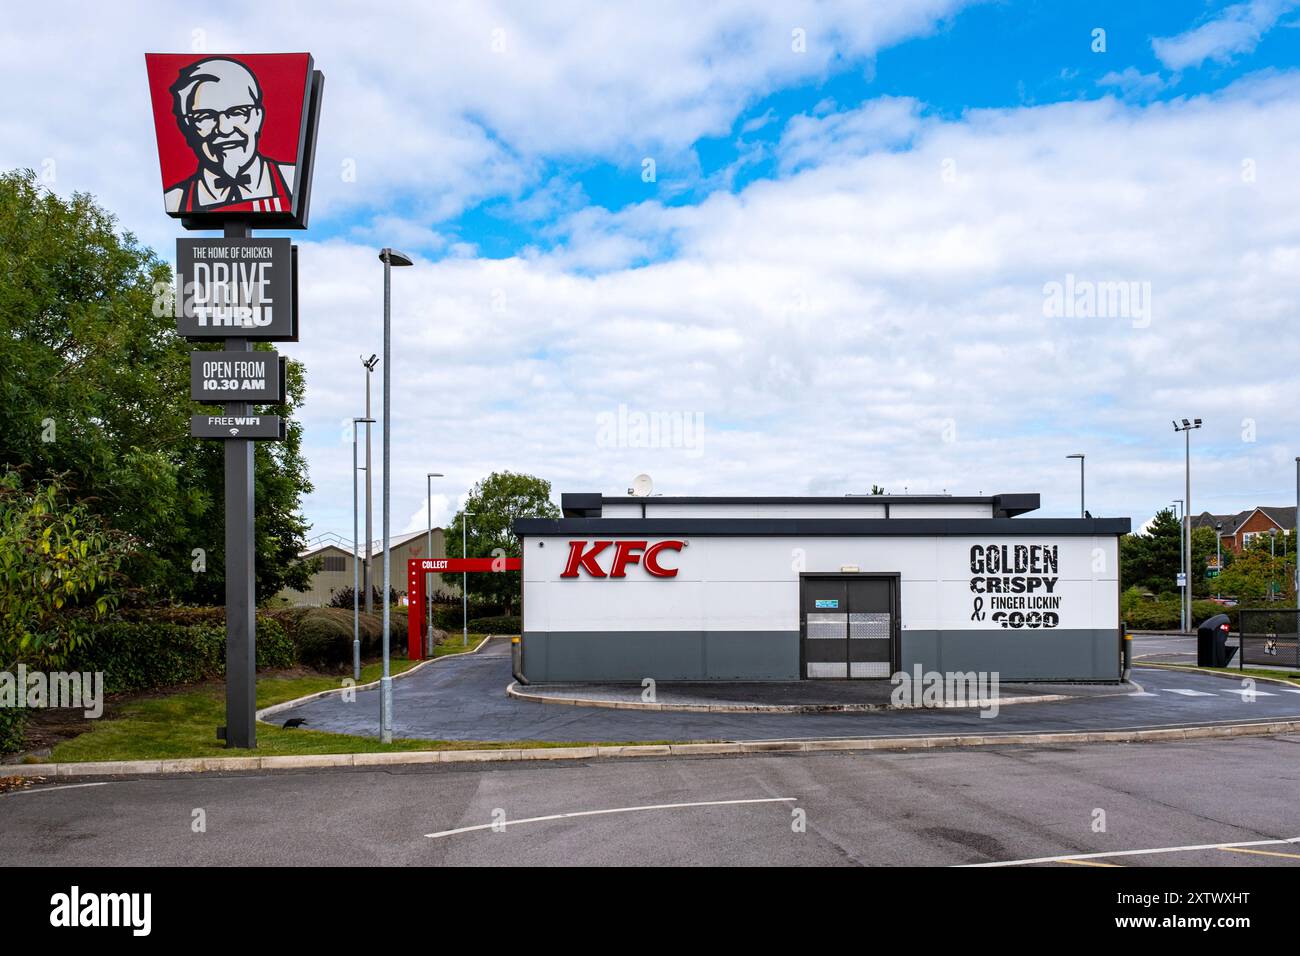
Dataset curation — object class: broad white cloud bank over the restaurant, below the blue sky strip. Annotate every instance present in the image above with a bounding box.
[295,74,1300,538]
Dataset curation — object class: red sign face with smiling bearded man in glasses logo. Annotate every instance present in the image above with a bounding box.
[147,53,311,220]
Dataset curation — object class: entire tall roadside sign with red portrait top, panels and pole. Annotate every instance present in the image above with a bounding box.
[144,53,325,748]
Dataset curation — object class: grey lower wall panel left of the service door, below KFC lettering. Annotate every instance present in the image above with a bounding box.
[523,631,800,683]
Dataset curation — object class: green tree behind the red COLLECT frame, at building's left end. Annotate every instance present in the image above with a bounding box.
[446,471,560,611]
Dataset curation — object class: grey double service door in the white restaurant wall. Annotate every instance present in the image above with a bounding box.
[800,575,898,679]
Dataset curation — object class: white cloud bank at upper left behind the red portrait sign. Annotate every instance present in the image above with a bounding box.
[0,0,967,248]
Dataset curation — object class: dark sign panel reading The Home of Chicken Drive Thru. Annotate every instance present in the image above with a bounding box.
[176,239,298,342]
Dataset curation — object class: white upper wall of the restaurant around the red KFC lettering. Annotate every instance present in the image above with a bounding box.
[524,535,1119,632]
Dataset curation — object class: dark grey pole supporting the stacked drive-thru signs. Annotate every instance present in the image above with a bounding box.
[221,221,257,749]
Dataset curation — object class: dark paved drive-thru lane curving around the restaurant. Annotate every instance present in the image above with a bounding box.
[273,640,1300,743]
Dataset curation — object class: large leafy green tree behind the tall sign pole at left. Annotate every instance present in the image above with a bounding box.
[0,170,311,602]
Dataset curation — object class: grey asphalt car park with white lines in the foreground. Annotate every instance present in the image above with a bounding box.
[0,735,1300,866]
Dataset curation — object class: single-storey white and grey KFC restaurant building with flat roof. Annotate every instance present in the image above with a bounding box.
[515,494,1130,683]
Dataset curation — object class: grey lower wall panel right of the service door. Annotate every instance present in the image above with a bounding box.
[900,627,1119,680]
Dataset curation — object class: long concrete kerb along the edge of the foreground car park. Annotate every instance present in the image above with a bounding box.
[10,721,1300,779]
